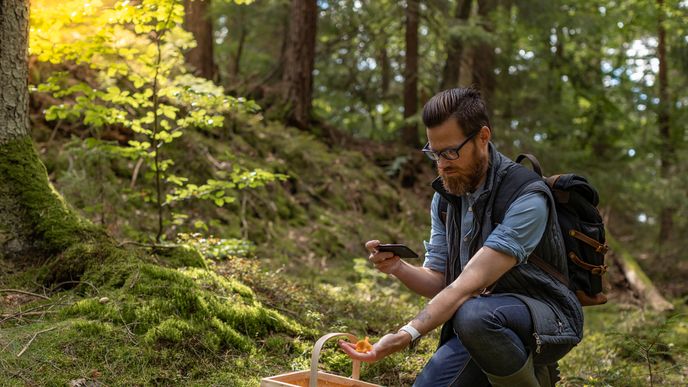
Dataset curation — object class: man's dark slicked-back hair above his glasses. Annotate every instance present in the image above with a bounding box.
[423,87,492,136]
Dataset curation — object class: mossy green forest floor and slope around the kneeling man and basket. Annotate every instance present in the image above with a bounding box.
[0,119,688,386]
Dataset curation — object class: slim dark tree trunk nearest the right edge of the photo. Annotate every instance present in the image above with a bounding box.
[657,0,676,247]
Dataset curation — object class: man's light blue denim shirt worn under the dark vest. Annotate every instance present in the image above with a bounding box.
[423,190,548,272]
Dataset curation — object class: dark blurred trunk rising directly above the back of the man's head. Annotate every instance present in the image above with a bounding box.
[473,0,497,117]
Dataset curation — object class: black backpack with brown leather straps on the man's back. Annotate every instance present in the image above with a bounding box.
[439,154,609,306]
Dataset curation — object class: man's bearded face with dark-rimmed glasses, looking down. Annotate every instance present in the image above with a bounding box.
[427,119,491,195]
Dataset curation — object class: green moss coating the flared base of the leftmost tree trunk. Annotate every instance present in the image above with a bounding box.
[0,137,103,255]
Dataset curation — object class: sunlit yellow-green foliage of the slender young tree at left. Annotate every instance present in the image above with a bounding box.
[30,0,285,239]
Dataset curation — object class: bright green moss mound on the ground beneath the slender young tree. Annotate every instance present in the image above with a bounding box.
[53,262,306,352]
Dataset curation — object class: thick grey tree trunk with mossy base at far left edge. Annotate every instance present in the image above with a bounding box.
[0,0,99,272]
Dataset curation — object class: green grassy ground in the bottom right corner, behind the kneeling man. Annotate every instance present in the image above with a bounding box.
[560,300,688,386]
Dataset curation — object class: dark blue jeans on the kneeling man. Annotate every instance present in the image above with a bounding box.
[413,294,535,387]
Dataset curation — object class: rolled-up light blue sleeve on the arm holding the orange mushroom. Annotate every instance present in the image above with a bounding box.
[484,192,548,264]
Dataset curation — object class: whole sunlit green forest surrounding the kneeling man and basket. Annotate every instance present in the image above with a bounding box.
[0,0,688,385]
